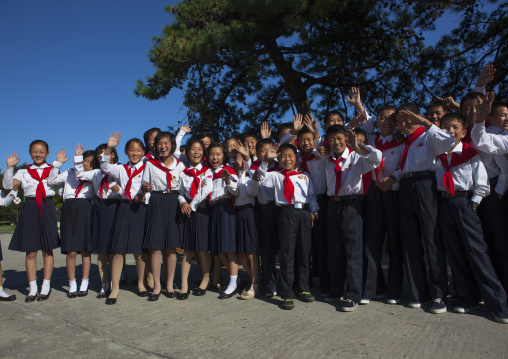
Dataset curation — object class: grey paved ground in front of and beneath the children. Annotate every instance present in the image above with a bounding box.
[0,234,508,359]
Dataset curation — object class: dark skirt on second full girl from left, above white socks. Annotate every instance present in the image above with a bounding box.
[60,198,92,254]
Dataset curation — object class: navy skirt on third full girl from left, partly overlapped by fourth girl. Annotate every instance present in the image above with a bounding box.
[92,197,120,254]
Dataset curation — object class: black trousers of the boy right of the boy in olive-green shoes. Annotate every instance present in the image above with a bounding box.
[327,199,363,303]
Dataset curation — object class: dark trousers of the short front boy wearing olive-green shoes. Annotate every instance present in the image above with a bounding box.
[279,207,312,299]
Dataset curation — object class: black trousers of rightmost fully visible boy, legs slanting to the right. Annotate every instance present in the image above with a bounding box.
[438,197,507,312]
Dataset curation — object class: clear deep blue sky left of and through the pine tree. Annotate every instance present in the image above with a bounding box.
[0,0,457,171]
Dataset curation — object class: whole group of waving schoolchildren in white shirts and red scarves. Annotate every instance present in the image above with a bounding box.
[0,68,508,323]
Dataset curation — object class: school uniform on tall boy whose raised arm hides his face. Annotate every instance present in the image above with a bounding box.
[399,125,455,303]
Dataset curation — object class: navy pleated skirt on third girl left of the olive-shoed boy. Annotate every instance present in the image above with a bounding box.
[182,199,210,252]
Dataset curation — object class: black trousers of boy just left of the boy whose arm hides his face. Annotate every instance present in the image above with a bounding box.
[363,185,403,299]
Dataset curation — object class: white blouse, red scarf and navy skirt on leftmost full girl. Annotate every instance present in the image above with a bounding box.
[3,163,59,252]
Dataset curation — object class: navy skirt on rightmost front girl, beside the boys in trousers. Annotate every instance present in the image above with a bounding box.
[235,206,259,253]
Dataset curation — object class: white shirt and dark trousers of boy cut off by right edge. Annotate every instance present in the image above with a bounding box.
[471,123,508,291]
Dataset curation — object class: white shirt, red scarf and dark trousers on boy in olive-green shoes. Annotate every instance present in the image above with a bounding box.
[258,161,319,299]
